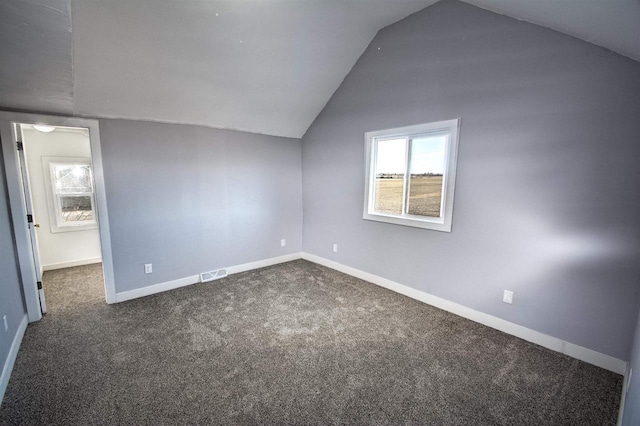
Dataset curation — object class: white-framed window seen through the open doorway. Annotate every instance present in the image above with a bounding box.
[43,157,97,232]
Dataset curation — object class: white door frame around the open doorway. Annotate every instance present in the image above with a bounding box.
[0,111,116,322]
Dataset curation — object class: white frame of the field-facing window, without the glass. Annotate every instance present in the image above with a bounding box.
[362,118,460,232]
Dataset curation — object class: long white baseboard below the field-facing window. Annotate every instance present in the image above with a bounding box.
[302,253,627,374]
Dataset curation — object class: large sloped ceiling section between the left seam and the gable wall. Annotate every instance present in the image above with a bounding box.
[72,0,440,137]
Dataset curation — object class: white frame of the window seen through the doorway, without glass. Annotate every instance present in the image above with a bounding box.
[42,157,98,233]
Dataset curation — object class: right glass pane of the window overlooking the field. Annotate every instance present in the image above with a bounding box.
[407,136,447,217]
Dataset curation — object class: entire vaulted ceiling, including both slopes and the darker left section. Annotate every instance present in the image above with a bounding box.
[0,0,640,137]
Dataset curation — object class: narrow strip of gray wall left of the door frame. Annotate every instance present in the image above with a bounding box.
[0,147,27,382]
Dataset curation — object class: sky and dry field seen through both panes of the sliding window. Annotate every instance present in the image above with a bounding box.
[374,136,446,217]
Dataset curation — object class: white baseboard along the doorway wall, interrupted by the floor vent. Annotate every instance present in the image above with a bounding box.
[116,253,302,303]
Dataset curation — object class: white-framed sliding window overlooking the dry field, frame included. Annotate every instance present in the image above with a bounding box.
[363,119,460,232]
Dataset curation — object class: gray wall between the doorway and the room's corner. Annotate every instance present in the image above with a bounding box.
[100,120,302,292]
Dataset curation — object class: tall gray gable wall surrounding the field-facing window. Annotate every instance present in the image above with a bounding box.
[303,1,640,360]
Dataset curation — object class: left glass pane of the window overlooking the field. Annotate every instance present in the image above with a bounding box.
[373,139,407,214]
